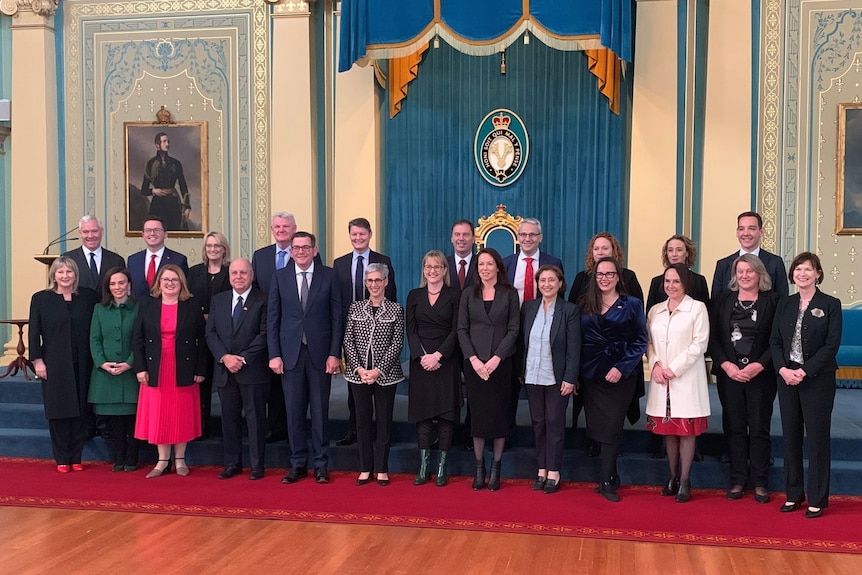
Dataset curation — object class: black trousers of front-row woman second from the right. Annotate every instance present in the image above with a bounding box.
[718,371,777,488]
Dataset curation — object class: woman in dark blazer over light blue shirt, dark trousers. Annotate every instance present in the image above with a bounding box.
[519,266,581,493]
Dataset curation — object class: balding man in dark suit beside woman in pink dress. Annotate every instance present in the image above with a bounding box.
[206,258,272,479]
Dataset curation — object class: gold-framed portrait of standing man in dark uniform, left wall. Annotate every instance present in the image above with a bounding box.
[123,122,209,238]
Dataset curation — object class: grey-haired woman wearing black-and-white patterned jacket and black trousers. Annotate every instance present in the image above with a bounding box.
[344,263,404,487]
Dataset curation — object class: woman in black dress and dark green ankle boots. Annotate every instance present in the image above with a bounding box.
[407,250,463,487]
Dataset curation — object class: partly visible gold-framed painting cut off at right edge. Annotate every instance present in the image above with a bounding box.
[835,103,862,236]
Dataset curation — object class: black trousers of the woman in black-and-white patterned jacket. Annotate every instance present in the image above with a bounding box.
[348,383,398,473]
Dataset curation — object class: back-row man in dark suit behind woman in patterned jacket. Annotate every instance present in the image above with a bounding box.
[332,218,396,446]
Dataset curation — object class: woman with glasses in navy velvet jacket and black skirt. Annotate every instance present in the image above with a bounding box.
[578,257,647,502]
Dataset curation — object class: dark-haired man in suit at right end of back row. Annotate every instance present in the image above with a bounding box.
[710,212,790,299]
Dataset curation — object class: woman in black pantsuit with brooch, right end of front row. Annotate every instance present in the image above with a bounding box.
[771,252,842,519]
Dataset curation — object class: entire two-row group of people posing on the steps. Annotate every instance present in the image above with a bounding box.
[30,212,841,518]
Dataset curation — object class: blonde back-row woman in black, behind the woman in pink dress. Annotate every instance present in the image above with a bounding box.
[188,232,230,437]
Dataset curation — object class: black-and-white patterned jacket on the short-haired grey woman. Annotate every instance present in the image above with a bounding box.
[344,299,404,385]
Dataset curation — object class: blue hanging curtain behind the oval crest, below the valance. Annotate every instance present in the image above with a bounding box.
[381,42,629,297]
